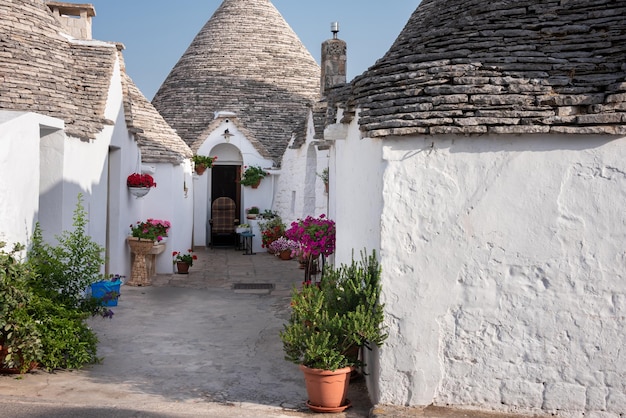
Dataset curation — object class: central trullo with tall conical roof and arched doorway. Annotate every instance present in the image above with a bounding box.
[152,0,328,251]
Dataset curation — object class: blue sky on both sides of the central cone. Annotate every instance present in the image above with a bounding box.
[89,0,421,100]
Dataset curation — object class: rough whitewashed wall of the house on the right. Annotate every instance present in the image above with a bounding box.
[326,108,626,418]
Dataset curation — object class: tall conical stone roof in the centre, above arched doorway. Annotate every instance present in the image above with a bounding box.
[152,0,320,165]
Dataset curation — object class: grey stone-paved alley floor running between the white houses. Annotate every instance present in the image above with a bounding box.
[0,248,371,417]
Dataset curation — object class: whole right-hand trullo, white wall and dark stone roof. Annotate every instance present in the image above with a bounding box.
[325,0,626,418]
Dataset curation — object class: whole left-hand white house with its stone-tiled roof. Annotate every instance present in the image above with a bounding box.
[0,0,193,276]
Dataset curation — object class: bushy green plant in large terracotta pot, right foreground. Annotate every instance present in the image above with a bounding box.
[280,253,387,412]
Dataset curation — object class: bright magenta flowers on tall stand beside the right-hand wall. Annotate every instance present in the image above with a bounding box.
[285,214,335,283]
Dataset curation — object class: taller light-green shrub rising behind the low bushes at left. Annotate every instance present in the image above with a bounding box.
[28,194,104,309]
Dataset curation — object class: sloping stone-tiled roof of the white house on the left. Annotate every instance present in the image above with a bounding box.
[0,0,191,163]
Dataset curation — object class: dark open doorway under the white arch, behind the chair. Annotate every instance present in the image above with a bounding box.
[209,165,241,246]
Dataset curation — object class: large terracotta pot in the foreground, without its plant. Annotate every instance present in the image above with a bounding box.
[300,365,352,412]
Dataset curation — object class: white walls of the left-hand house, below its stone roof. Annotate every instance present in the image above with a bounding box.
[0,54,193,276]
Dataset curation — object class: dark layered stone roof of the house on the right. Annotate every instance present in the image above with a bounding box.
[351,0,626,137]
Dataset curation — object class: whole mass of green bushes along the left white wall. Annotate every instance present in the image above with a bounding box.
[0,194,112,372]
